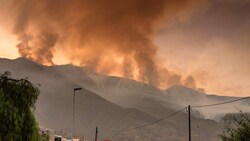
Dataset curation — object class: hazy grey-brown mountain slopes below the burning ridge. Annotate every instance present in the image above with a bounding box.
[0,58,250,141]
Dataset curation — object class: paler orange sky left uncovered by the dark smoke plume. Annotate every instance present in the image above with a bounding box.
[0,0,250,96]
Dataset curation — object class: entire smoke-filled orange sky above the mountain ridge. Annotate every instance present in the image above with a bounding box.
[0,0,250,95]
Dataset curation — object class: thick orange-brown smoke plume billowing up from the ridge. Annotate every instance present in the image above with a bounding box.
[4,0,208,87]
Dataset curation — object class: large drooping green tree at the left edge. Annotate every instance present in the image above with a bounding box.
[0,72,47,141]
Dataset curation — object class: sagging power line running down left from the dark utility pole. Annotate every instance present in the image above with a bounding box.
[112,107,187,138]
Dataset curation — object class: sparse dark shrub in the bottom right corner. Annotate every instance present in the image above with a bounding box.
[220,108,250,141]
